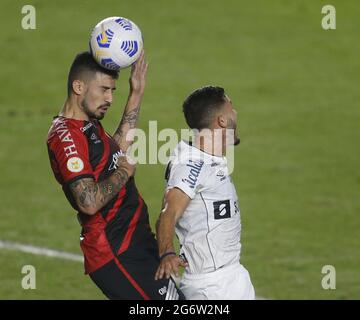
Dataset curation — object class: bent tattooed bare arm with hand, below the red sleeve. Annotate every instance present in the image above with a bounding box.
[69,156,135,215]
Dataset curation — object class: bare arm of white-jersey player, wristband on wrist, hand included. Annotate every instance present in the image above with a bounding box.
[155,188,191,280]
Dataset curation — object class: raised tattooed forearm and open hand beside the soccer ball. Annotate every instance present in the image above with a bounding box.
[113,51,148,152]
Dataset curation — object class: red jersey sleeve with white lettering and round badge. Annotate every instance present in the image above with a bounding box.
[51,128,94,184]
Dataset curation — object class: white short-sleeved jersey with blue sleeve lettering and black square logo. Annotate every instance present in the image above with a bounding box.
[166,141,241,274]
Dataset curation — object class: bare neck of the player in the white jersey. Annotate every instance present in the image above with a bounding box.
[193,130,225,157]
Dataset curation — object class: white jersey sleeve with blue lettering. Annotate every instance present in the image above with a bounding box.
[166,160,206,199]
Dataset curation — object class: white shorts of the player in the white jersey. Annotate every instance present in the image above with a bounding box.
[180,264,255,300]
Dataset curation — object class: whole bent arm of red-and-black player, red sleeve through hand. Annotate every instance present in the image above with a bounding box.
[47,117,135,215]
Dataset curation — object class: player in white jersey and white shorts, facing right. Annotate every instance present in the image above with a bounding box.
[155,86,255,300]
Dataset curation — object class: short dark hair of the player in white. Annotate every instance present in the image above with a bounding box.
[183,86,226,130]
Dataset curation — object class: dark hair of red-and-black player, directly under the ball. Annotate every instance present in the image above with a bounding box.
[68,51,119,96]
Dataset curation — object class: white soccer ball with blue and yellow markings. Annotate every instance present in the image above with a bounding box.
[90,17,143,70]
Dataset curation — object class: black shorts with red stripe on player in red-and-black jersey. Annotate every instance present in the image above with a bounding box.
[89,256,185,300]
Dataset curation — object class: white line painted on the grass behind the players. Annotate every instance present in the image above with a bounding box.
[0,240,266,300]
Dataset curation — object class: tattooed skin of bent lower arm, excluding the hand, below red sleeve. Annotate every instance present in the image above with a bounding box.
[70,166,129,209]
